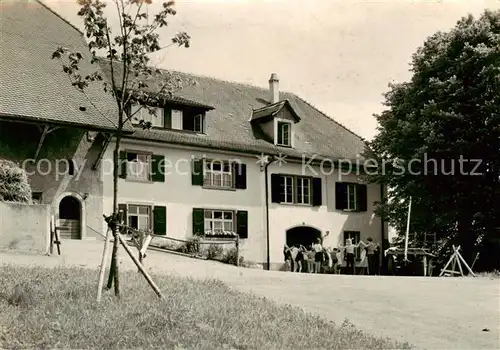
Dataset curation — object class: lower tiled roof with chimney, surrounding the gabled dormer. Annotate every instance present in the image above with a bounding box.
[101,59,366,159]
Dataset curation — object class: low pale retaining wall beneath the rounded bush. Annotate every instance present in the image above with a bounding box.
[0,202,50,253]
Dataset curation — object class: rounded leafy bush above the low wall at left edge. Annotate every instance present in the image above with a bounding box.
[0,159,31,203]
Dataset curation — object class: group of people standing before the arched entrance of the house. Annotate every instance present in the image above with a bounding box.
[283,237,379,275]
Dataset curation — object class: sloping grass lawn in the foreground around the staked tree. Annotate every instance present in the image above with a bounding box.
[0,265,410,349]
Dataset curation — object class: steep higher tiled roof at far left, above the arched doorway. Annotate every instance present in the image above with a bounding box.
[0,0,125,129]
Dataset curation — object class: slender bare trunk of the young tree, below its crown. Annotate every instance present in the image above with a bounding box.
[107,133,121,297]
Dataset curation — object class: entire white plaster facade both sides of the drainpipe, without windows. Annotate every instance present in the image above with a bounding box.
[102,140,382,268]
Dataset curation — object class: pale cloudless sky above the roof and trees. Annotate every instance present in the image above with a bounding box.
[43,0,500,140]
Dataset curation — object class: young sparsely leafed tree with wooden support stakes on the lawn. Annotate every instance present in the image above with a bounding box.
[52,0,190,300]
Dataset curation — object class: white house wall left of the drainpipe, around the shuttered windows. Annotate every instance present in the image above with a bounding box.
[99,140,266,262]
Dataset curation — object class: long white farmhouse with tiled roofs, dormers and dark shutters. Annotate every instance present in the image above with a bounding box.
[0,2,387,269]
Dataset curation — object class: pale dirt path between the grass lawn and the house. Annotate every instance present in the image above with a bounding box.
[0,241,500,349]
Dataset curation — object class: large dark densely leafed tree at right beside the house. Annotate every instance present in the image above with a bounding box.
[369,10,500,269]
